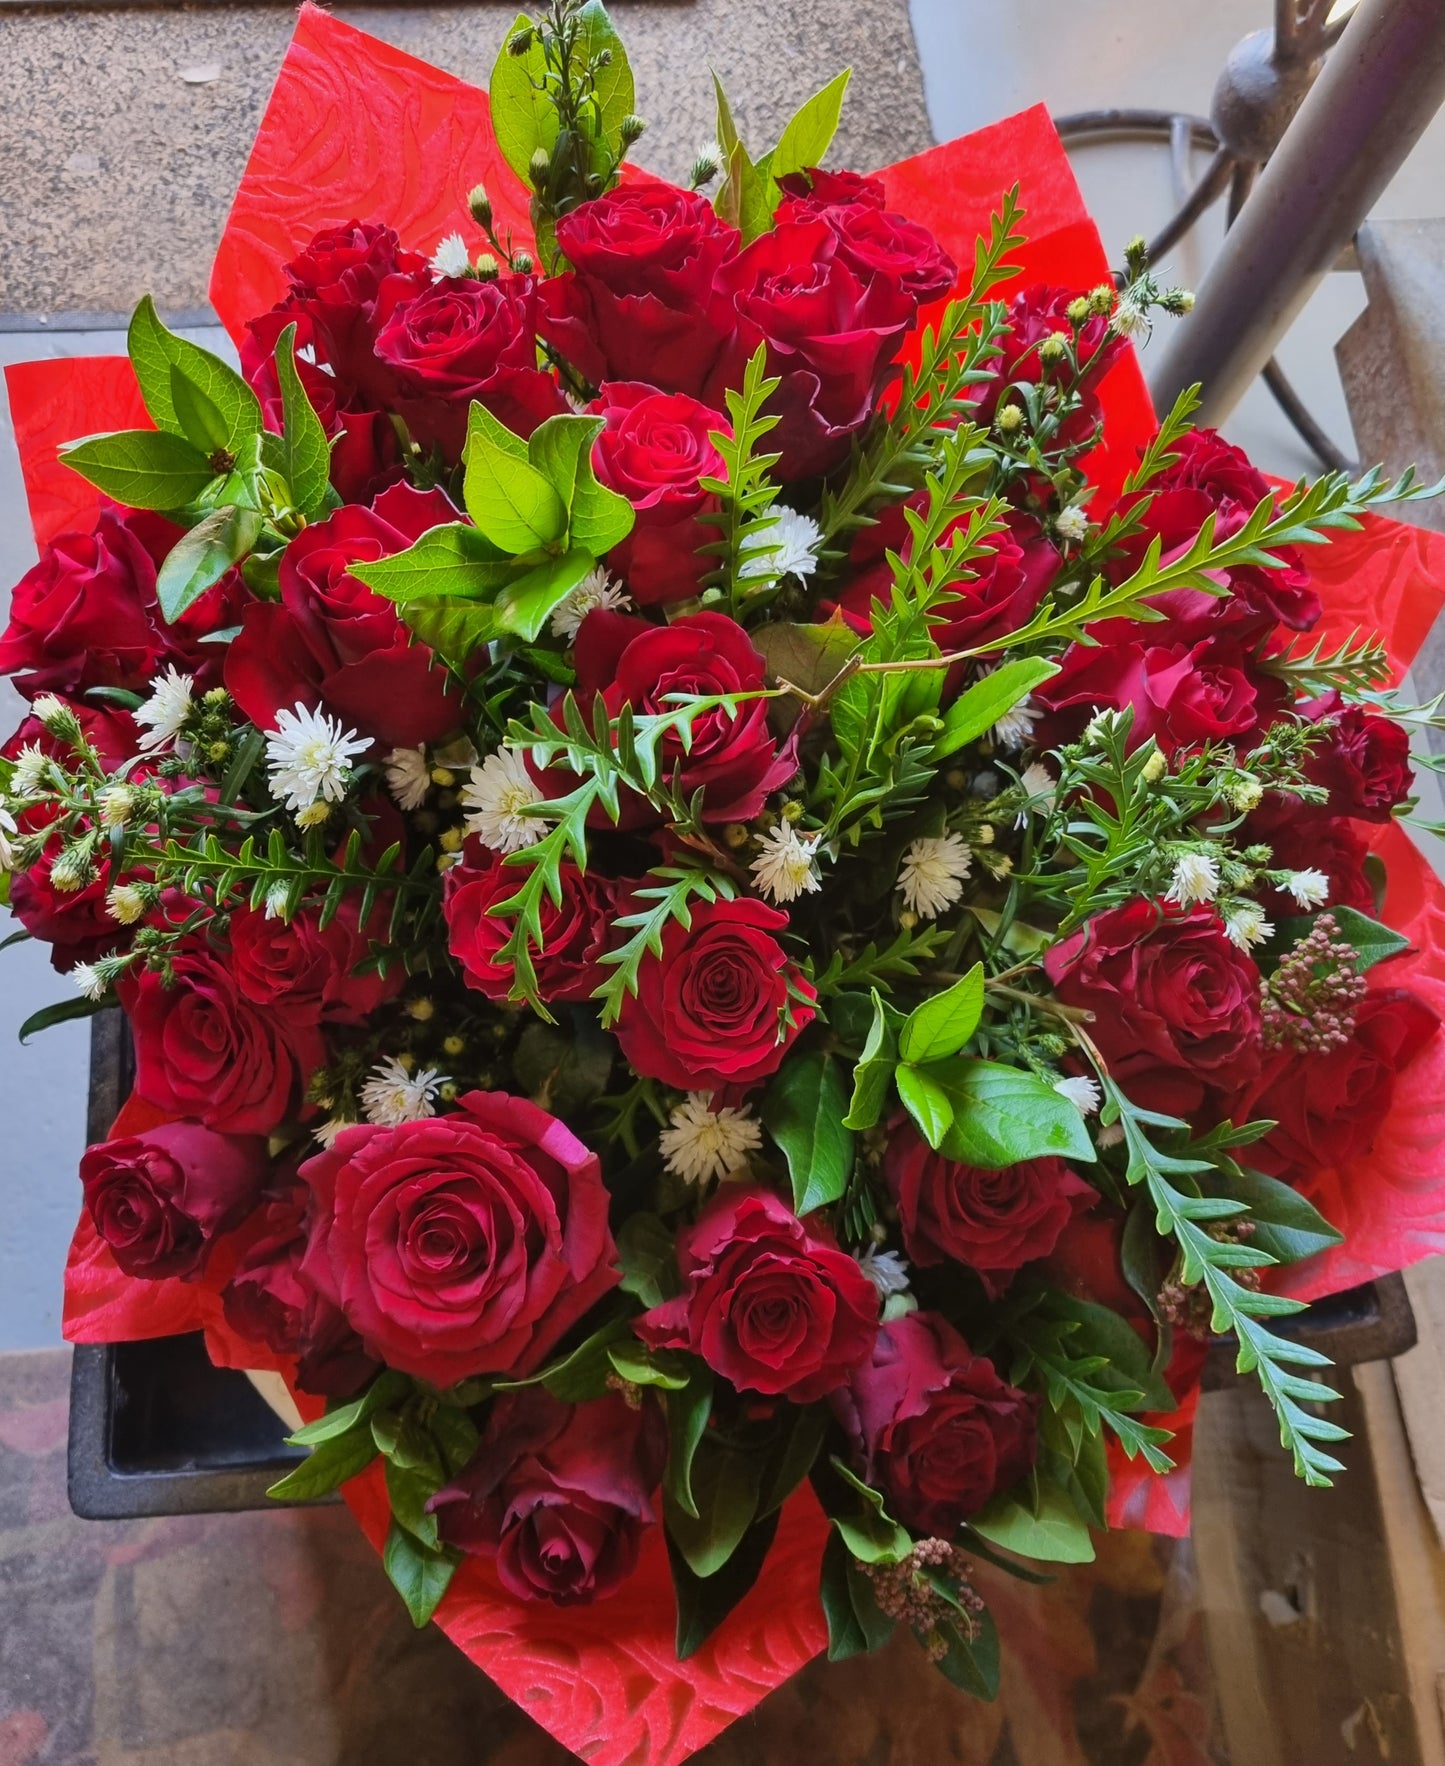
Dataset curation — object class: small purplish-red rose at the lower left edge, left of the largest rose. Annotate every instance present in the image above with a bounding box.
[79,1121,267,1280]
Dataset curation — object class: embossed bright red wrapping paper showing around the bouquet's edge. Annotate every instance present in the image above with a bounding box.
[7,5,1445,1766]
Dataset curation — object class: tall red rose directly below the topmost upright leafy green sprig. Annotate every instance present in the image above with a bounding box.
[541,178,740,396]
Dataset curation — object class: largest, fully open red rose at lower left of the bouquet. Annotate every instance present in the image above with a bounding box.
[300,1091,618,1386]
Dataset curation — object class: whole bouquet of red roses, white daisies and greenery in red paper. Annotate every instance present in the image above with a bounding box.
[0,0,1445,1766]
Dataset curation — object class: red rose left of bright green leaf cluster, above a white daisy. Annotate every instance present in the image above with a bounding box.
[226,484,461,759]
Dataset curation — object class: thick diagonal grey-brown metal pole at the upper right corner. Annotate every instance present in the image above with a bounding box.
[1150,0,1445,424]
